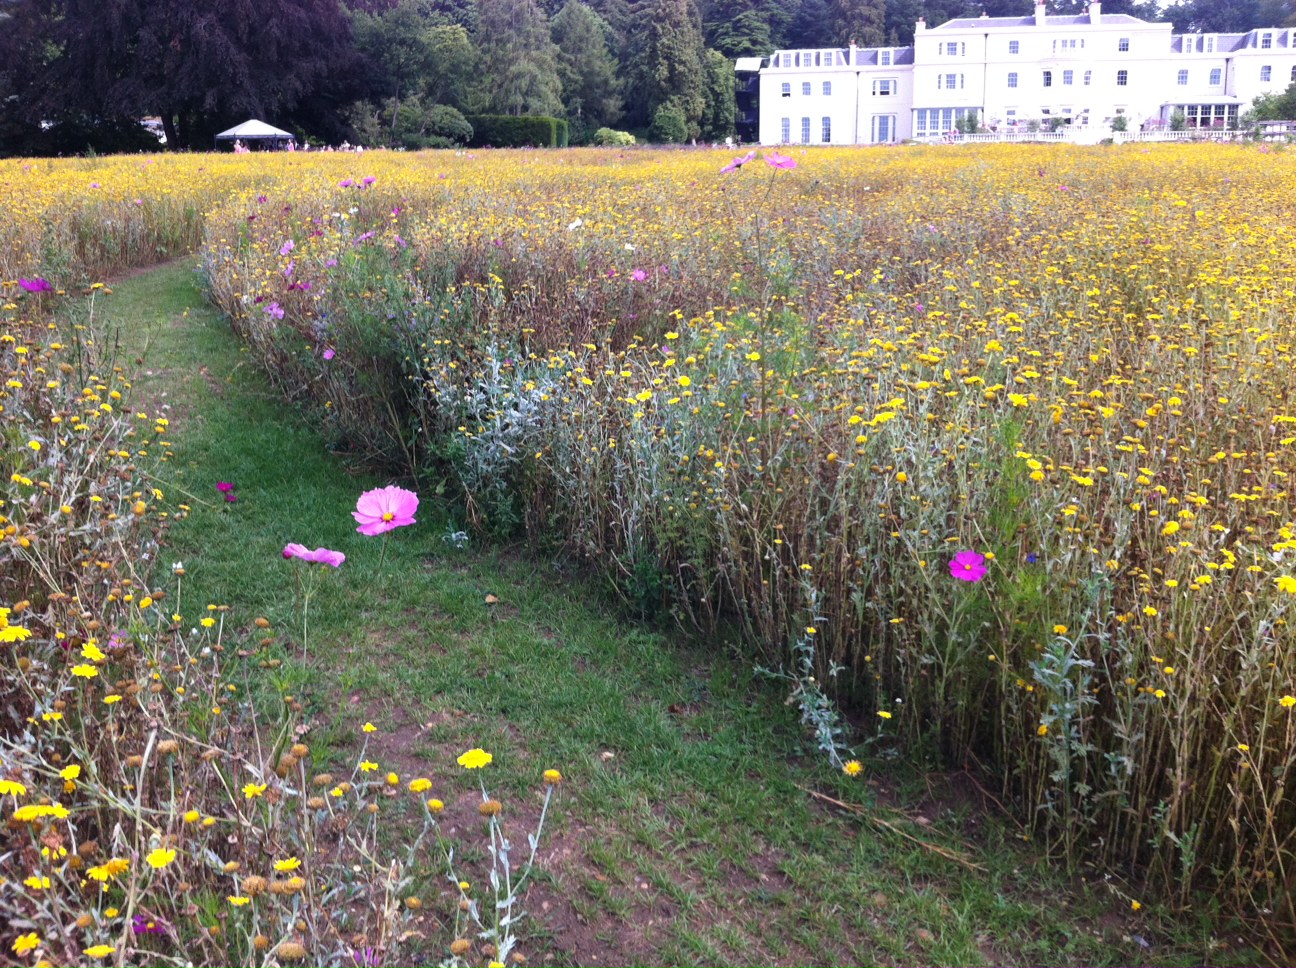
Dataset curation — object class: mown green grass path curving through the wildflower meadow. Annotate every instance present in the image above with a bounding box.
[105,262,1260,968]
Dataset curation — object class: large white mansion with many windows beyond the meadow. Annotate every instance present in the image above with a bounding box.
[737,3,1296,145]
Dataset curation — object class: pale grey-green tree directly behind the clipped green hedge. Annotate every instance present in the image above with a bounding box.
[477,0,562,114]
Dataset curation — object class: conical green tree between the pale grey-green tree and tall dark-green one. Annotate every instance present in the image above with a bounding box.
[550,0,621,130]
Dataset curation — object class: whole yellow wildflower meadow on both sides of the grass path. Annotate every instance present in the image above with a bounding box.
[0,144,1296,967]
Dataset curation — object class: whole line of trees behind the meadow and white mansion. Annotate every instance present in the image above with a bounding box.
[0,0,1293,154]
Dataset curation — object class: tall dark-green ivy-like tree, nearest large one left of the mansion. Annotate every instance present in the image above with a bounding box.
[635,0,706,137]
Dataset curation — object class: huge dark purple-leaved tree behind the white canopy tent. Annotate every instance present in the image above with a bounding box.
[0,0,354,148]
